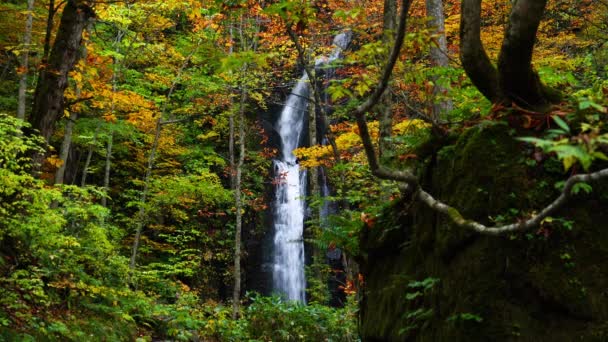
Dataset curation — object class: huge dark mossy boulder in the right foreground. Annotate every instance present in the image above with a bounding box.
[360,125,608,341]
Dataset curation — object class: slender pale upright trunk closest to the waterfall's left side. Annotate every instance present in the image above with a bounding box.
[232,89,247,319]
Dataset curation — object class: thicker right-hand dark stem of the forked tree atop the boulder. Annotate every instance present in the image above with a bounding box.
[498,0,550,109]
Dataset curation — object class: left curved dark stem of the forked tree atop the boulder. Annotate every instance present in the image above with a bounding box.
[460,0,502,102]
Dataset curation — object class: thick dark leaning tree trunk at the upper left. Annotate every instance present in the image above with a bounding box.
[29,0,94,142]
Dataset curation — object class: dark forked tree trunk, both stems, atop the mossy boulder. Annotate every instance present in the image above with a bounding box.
[460,0,559,111]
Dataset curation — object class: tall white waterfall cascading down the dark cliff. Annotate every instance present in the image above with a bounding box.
[272,32,351,302]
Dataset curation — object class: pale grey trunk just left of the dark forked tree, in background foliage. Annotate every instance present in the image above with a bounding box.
[426,0,453,122]
